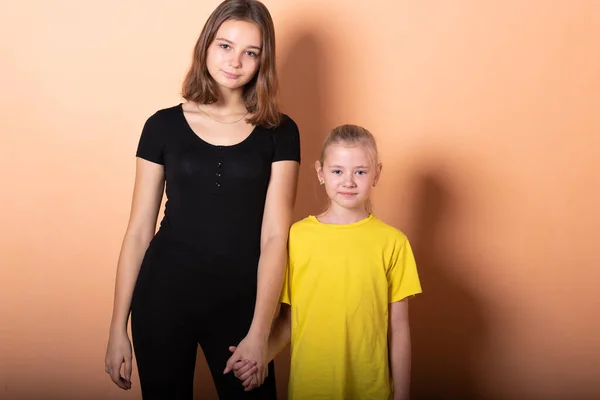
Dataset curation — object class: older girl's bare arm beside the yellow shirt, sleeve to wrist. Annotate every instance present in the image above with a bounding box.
[248,161,299,342]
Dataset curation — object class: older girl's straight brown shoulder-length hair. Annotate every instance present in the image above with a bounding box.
[182,0,281,128]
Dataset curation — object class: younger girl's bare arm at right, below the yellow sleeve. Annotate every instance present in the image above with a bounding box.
[389,299,411,400]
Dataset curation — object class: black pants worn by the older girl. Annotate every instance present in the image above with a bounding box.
[131,244,277,400]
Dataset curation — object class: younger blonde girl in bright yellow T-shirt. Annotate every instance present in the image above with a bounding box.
[230,125,421,400]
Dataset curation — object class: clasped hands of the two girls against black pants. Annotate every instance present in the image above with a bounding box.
[223,336,268,391]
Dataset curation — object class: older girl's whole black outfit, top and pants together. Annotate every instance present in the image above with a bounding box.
[131,104,300,399]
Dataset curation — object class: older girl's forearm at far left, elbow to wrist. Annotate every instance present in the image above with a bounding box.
[110,233,152,332]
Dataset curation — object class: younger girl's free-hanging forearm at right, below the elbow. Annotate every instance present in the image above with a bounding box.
[390,324,411,400]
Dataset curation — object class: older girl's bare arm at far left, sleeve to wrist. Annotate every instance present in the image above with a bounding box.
[110,158,164,334]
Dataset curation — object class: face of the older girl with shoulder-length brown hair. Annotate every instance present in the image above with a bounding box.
[206,20,262,90]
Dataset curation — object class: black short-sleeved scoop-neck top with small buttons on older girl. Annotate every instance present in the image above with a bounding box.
[136,104,300,275]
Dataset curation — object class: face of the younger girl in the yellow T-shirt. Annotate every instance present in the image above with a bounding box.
[315,143,381,209]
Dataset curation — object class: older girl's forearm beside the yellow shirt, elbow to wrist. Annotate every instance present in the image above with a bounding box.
[249,236,287,340]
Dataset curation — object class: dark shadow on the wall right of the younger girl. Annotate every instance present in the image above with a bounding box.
[410,172,486,400]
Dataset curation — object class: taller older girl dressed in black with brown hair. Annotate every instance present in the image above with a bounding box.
[106,0,300,399]
